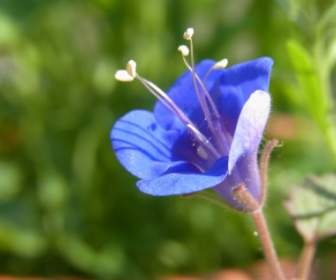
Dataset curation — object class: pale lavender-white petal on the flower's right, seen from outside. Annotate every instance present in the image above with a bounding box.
[228,90,271,174]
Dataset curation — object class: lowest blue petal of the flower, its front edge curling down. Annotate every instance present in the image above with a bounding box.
[137,157,227,196]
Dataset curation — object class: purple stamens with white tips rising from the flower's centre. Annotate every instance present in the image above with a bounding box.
[115,28,231,168]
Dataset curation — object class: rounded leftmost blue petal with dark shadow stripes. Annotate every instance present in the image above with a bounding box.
[111,110,185,179]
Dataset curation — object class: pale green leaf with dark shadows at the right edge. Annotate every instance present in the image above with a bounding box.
[286,174,336,242]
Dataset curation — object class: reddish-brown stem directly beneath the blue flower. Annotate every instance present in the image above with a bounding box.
[251,209,286,280]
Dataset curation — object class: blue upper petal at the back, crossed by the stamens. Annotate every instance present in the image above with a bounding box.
[154,60,215,129]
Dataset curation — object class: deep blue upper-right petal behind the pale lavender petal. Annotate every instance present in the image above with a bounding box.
[211,57,273,135]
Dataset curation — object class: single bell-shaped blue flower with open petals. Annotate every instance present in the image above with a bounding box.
[111,57,273,209]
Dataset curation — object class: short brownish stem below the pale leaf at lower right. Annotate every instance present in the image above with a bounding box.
[297,241,316,280]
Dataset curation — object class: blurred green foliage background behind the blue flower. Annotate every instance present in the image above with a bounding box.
[0,0,336,279]
